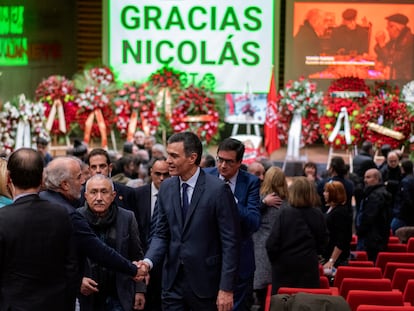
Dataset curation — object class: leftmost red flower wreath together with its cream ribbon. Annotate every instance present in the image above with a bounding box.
[35,75,78,135]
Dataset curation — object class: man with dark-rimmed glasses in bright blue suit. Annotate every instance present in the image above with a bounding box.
[205,138,261,311]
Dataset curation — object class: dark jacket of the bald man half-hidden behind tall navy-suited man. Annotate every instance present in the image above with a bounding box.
[134,184,151,251]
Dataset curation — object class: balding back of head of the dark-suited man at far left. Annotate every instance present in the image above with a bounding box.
[7,148,43,190]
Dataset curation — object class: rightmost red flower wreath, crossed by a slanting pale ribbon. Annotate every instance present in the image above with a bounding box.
[358,94,412,148]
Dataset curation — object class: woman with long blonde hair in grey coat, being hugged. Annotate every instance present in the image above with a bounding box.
[253,166,288,310]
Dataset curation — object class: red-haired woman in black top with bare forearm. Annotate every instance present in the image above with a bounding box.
[323,181,352,269]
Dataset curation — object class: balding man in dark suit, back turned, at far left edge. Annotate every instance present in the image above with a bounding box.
[0,148,74,311]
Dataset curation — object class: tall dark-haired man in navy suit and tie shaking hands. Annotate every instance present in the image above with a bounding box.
[139,132,240,311]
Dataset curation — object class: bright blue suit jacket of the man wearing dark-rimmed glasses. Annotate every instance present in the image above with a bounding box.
[205,167,261,279]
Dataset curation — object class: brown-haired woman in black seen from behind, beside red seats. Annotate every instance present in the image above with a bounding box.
[266,177,328,294]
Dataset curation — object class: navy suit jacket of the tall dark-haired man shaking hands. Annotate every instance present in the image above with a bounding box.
[145,171,240,299]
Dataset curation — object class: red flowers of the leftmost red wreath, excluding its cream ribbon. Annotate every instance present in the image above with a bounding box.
[35,75,78,135]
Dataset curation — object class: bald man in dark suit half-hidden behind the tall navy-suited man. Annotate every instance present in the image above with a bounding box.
[135,158,170,311]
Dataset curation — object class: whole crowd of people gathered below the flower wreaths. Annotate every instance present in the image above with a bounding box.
[0,131,414,311]
